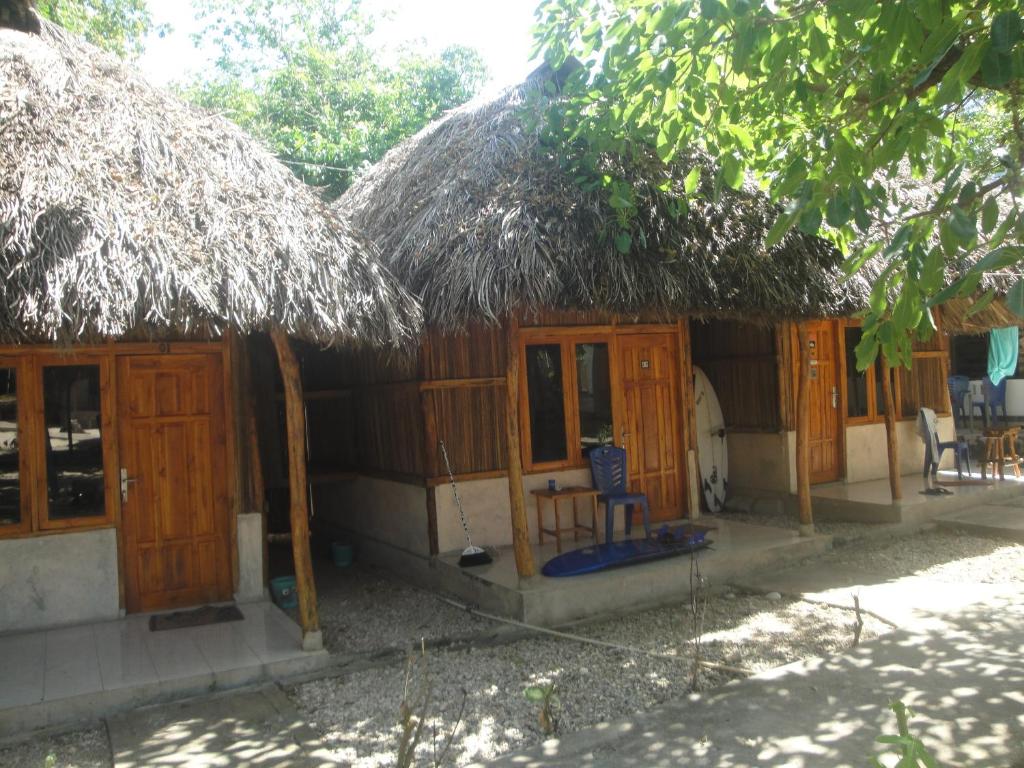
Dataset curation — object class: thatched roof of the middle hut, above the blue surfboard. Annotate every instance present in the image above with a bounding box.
[339,68,865,330]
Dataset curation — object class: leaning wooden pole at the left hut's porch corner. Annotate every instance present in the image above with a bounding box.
[270,329,324,650]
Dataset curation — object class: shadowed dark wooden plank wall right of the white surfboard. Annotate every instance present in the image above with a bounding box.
[690,319,782,432]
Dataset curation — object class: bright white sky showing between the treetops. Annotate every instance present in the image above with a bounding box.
[139,0,539,91]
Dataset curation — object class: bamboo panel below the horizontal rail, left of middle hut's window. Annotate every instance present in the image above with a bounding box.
[431,386,508,474]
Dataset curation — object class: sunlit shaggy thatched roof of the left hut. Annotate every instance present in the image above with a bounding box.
[0,15,419,343]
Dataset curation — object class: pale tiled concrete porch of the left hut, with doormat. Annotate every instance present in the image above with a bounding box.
[0,601,328,736]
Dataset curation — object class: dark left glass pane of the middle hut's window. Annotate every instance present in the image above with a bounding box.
[526,344,568,464]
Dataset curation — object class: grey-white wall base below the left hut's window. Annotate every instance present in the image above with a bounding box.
[0,528,120,632]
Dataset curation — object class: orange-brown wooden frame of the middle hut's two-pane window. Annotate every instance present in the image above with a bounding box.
[519,329,618,473]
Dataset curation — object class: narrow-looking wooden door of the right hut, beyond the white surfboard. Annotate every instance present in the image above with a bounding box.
[806,321,842,482]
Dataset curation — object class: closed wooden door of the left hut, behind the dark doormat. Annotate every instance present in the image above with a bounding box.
[118,352,231,611]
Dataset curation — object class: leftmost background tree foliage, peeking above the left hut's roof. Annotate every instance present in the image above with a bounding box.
[37,0,166,56]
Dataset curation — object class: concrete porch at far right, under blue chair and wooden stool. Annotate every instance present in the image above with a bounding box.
[806,469,1024,523]
